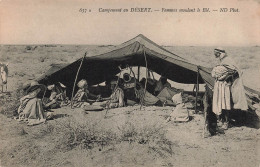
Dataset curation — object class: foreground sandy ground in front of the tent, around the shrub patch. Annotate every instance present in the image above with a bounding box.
[0,106,260,167]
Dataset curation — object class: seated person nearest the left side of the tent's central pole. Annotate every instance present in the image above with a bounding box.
[93,80,125,108]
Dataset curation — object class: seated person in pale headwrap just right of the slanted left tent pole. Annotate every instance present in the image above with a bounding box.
[72,79,100,108]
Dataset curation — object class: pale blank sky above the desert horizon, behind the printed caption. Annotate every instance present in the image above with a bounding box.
[0,0,260,46]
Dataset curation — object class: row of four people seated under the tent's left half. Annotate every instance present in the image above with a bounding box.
[15,79,125,125]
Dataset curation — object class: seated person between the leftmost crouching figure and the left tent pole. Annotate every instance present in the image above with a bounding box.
[44,82,68,109]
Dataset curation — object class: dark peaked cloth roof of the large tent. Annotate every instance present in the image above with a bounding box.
[38,34,260,109]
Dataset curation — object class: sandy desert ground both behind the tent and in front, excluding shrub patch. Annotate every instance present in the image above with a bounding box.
[0,45,260,167]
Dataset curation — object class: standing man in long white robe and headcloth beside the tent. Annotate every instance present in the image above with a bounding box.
[211,48,248,130]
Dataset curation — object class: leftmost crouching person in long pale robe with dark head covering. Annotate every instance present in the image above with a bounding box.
[18,81,52,125]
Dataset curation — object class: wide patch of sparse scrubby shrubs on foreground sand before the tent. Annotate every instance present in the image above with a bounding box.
[55,118,173,156]
